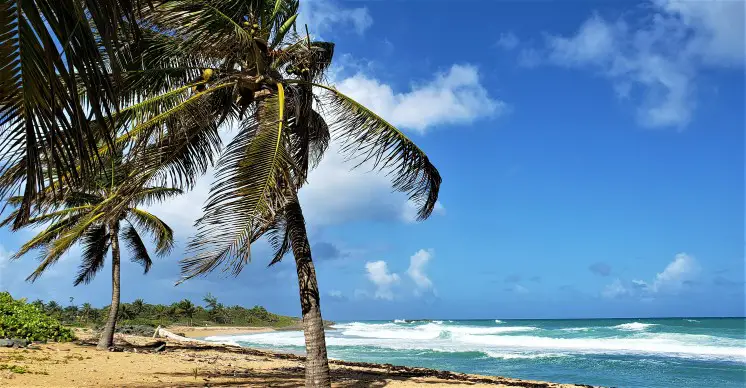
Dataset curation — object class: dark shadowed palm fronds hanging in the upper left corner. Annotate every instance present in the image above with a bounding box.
[0,0,137,224]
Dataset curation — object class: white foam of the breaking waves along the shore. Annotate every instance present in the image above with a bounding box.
[202,322,746,363]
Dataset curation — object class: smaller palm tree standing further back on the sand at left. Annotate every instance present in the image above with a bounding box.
[0,159,181,349]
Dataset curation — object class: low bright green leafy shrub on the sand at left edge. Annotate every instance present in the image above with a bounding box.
[0,292,74,341]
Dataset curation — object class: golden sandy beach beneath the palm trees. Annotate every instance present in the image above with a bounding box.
[0,327,592,388]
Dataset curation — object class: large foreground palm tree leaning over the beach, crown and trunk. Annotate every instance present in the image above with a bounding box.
[97,0,441,387]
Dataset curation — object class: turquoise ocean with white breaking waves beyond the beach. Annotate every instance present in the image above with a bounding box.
[201,318,746,388]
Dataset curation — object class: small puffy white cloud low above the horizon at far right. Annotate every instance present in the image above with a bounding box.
[601,253,700,298]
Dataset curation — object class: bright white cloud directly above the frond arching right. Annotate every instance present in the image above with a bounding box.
[336,64,507,133]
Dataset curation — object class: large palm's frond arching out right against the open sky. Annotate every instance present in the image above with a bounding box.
[314,84,441,220]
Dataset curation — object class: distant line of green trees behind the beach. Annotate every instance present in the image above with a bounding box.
[31,293,299,327]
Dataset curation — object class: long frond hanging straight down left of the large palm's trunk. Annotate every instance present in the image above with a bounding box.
[181,85,296,278]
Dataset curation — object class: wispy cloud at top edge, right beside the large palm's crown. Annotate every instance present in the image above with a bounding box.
[298,0,373,35]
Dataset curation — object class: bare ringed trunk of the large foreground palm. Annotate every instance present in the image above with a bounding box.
[286,199,331,388]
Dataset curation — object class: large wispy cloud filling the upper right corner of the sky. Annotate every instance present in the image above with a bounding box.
[536,0,744,128]
